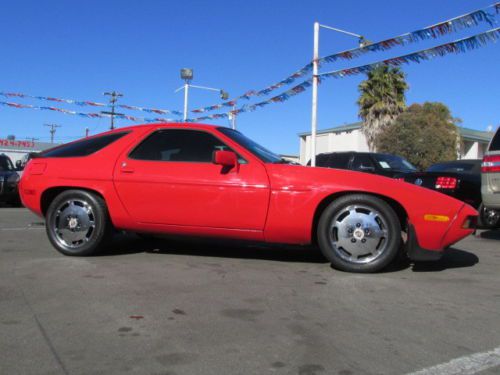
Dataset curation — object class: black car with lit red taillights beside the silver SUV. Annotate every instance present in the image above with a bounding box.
[395,159,500,228]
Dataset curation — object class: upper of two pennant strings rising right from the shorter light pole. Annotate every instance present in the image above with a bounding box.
[191,2,500,113]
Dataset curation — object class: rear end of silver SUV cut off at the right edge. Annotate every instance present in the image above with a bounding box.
[481,128,500,225]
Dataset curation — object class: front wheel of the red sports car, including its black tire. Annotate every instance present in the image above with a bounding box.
[317,194,401,273]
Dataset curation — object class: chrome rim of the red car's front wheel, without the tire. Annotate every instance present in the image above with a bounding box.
[329,204,389,264]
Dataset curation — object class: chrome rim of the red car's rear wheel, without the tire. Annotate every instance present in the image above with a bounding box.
[50,199,96,249]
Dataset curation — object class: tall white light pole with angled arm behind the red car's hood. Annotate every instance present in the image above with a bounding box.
[311,22,371,167]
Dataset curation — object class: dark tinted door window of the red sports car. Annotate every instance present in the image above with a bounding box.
[129,129,238,163]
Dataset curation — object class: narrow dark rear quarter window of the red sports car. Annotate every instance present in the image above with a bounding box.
[40,132,128,158]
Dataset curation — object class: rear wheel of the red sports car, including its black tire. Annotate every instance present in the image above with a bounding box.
[45,190,112,256]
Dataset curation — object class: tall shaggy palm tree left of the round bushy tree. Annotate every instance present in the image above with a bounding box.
[358,65,408,151]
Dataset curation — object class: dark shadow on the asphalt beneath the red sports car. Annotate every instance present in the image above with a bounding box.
[101,234,479,273]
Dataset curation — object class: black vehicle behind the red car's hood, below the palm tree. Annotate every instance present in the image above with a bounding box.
[308,151,417,177]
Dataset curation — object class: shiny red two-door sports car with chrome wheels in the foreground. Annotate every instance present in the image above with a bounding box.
[20,123,477,272]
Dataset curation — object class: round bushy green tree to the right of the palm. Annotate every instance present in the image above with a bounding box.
[376,102,459,169]
